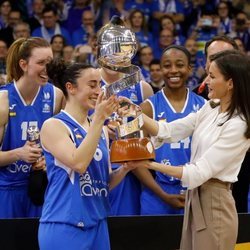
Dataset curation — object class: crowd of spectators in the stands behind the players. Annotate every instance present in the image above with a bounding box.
[0,0,250,89]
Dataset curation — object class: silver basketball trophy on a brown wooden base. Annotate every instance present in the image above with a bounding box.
[97,16,155,162]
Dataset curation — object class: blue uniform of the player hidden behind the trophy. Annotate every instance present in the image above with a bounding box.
[102,81,143,216]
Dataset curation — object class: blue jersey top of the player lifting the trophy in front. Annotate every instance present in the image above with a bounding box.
[40,111,109,228]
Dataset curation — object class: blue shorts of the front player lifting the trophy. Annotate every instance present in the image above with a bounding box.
[38,219,110,250]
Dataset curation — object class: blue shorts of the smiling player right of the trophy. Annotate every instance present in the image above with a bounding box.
[141,182,184,215]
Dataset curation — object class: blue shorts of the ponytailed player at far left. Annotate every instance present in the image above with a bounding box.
[0,186,42,219]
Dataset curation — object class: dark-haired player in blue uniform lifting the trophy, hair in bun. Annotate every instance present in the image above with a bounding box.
[39,61,137,250]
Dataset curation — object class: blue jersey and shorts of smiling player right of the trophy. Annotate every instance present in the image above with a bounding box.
[141,89,205,215]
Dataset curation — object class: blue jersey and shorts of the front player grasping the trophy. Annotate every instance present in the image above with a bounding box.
[39,111,110,250]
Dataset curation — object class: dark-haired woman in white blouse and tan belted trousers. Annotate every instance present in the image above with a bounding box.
[128,50,250,250]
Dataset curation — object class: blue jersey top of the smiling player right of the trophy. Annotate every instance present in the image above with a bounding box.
[148,90,205,184]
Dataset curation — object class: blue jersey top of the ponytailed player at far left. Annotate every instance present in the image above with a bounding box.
[0,83,55,187]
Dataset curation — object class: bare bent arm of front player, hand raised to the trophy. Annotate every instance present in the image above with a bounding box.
[41,93,117,173]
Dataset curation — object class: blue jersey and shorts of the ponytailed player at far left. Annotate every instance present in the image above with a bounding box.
[0,83,55,218]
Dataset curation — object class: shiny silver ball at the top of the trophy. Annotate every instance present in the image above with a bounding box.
[97,16,137,67]
